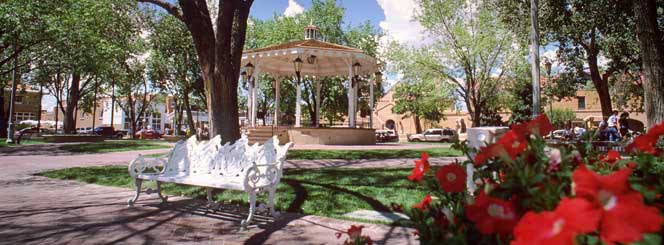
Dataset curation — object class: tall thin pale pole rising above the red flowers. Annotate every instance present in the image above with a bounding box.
[530,0,540,118]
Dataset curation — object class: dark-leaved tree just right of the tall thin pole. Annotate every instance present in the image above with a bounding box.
[496,0,640,117]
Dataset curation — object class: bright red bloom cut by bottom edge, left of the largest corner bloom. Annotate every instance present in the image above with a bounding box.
[512,198,600,245]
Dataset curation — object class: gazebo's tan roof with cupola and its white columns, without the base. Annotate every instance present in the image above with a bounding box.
[242,25,382,143]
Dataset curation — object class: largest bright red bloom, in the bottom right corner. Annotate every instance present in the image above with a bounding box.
[572,165,664,244]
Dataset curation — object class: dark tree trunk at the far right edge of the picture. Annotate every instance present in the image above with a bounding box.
[634,0,664,128]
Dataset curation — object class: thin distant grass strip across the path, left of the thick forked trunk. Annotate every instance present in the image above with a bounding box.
[60,140,171,153]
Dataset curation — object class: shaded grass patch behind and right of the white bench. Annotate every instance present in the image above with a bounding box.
[39,166,428,222]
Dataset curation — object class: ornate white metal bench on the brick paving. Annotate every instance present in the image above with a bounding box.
[127,136,292,227]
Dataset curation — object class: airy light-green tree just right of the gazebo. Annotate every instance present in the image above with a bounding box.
[388,0,518,126]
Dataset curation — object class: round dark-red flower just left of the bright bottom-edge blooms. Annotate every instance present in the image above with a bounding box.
[465,191,519,235]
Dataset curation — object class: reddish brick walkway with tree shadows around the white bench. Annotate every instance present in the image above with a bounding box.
[0,146,462,244]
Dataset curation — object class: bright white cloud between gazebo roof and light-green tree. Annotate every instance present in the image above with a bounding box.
[377,0,424,44]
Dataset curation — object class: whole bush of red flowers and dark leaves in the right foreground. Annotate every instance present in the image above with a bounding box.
[404,116,664,244]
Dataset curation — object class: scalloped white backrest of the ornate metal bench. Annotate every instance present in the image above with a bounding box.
[164,136,292,178]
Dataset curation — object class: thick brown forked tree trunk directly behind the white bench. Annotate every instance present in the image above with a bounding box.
[147,0,253,145]
